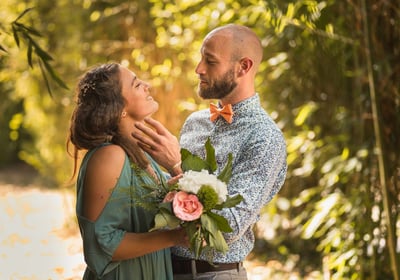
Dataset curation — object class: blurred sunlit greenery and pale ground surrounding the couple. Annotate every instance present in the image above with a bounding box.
[0,0,400,280]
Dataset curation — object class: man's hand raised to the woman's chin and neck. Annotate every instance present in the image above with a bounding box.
[132,118,182,175]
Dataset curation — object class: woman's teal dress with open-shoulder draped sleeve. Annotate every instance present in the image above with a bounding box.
[76,145,173,280]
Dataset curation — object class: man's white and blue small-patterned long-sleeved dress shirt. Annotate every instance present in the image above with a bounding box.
[172,94,287,263]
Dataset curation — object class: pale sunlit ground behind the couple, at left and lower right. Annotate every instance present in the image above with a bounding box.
[0,165,317,280]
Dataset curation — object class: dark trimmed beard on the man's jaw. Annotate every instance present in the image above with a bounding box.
[198,69,237,99]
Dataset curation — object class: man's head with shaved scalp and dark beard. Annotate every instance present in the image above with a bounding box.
[196,24,263,103]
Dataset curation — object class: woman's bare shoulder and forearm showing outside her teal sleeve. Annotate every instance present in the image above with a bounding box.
[83,145,187,261]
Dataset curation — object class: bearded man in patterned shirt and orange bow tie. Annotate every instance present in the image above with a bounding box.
[134,24,287,279]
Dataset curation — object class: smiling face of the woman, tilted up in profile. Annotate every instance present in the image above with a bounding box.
[120,66,158,121]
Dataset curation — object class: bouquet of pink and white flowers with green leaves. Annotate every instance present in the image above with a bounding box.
[138,139,243,259]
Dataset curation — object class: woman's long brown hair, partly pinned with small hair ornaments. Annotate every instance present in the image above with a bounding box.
[67,63,148,177]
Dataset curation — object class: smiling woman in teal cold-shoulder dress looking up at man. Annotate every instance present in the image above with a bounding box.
[69,63,187,280]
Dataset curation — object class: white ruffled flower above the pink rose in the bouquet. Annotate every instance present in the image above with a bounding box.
[178,170,228,203]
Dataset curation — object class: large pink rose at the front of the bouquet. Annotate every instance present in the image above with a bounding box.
[172,191,203,221]
